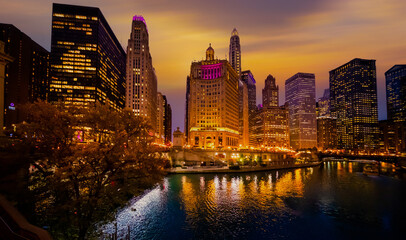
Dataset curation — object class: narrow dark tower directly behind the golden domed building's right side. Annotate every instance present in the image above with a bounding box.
[241,70,257,146]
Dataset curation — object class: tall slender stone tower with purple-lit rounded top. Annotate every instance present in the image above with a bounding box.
[126,15,157,129]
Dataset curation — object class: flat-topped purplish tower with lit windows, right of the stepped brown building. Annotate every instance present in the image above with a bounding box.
[285,73,317,149]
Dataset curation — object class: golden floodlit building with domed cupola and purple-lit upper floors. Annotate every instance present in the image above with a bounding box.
[186,46,239,149]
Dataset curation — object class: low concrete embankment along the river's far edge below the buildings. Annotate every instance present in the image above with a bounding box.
[167,162,322,174]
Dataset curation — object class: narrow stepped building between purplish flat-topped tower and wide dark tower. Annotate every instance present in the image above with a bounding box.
[317,89,337,150]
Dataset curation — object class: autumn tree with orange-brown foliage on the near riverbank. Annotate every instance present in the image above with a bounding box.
[17,101,166,239]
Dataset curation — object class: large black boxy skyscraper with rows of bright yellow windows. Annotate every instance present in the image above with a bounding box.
[49,3,126,110]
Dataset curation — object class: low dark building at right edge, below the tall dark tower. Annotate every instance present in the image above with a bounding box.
[379,120,406,154]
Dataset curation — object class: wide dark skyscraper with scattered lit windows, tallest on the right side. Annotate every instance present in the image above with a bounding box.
[330,58,379,151]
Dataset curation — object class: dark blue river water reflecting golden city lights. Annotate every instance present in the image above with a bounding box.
[103,161,406,240]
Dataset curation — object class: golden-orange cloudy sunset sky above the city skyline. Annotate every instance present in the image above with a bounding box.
[0,0,406,130]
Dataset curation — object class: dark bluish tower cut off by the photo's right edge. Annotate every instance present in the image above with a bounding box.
[385,64,406,122]
